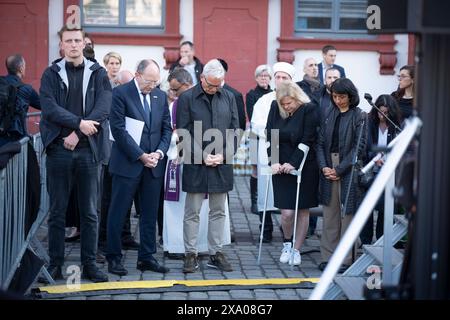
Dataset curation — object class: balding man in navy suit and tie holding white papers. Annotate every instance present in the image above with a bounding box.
[106,59,172,276]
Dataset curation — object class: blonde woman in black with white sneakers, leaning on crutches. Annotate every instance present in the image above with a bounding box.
[266,81,319,265]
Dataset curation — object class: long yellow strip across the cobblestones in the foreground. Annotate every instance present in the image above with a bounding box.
[39,278,320,294]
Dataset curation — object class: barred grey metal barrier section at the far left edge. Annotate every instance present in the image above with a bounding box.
[0,137,29,290]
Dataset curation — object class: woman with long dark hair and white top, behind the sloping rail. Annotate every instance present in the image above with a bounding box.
[360,94,401,244]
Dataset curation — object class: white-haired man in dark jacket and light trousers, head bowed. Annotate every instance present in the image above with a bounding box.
[176,59,239,273]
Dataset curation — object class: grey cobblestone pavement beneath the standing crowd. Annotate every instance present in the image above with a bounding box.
[34,176,321,300]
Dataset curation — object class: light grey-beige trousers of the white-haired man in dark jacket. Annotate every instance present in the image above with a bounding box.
[183,192,227,255]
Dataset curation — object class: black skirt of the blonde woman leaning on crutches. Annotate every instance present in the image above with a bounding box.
[272,161,319,210]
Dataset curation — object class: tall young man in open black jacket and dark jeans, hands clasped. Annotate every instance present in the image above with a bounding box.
[40,26,112,282]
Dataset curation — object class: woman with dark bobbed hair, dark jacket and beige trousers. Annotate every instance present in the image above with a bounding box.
[317,78,367,271]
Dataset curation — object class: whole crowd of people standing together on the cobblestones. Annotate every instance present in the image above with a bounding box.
[1,26,414,282]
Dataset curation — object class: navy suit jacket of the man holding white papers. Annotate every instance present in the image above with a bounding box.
[109,80,172,178]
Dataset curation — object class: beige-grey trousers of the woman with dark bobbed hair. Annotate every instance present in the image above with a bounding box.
[320,153,353,265]
